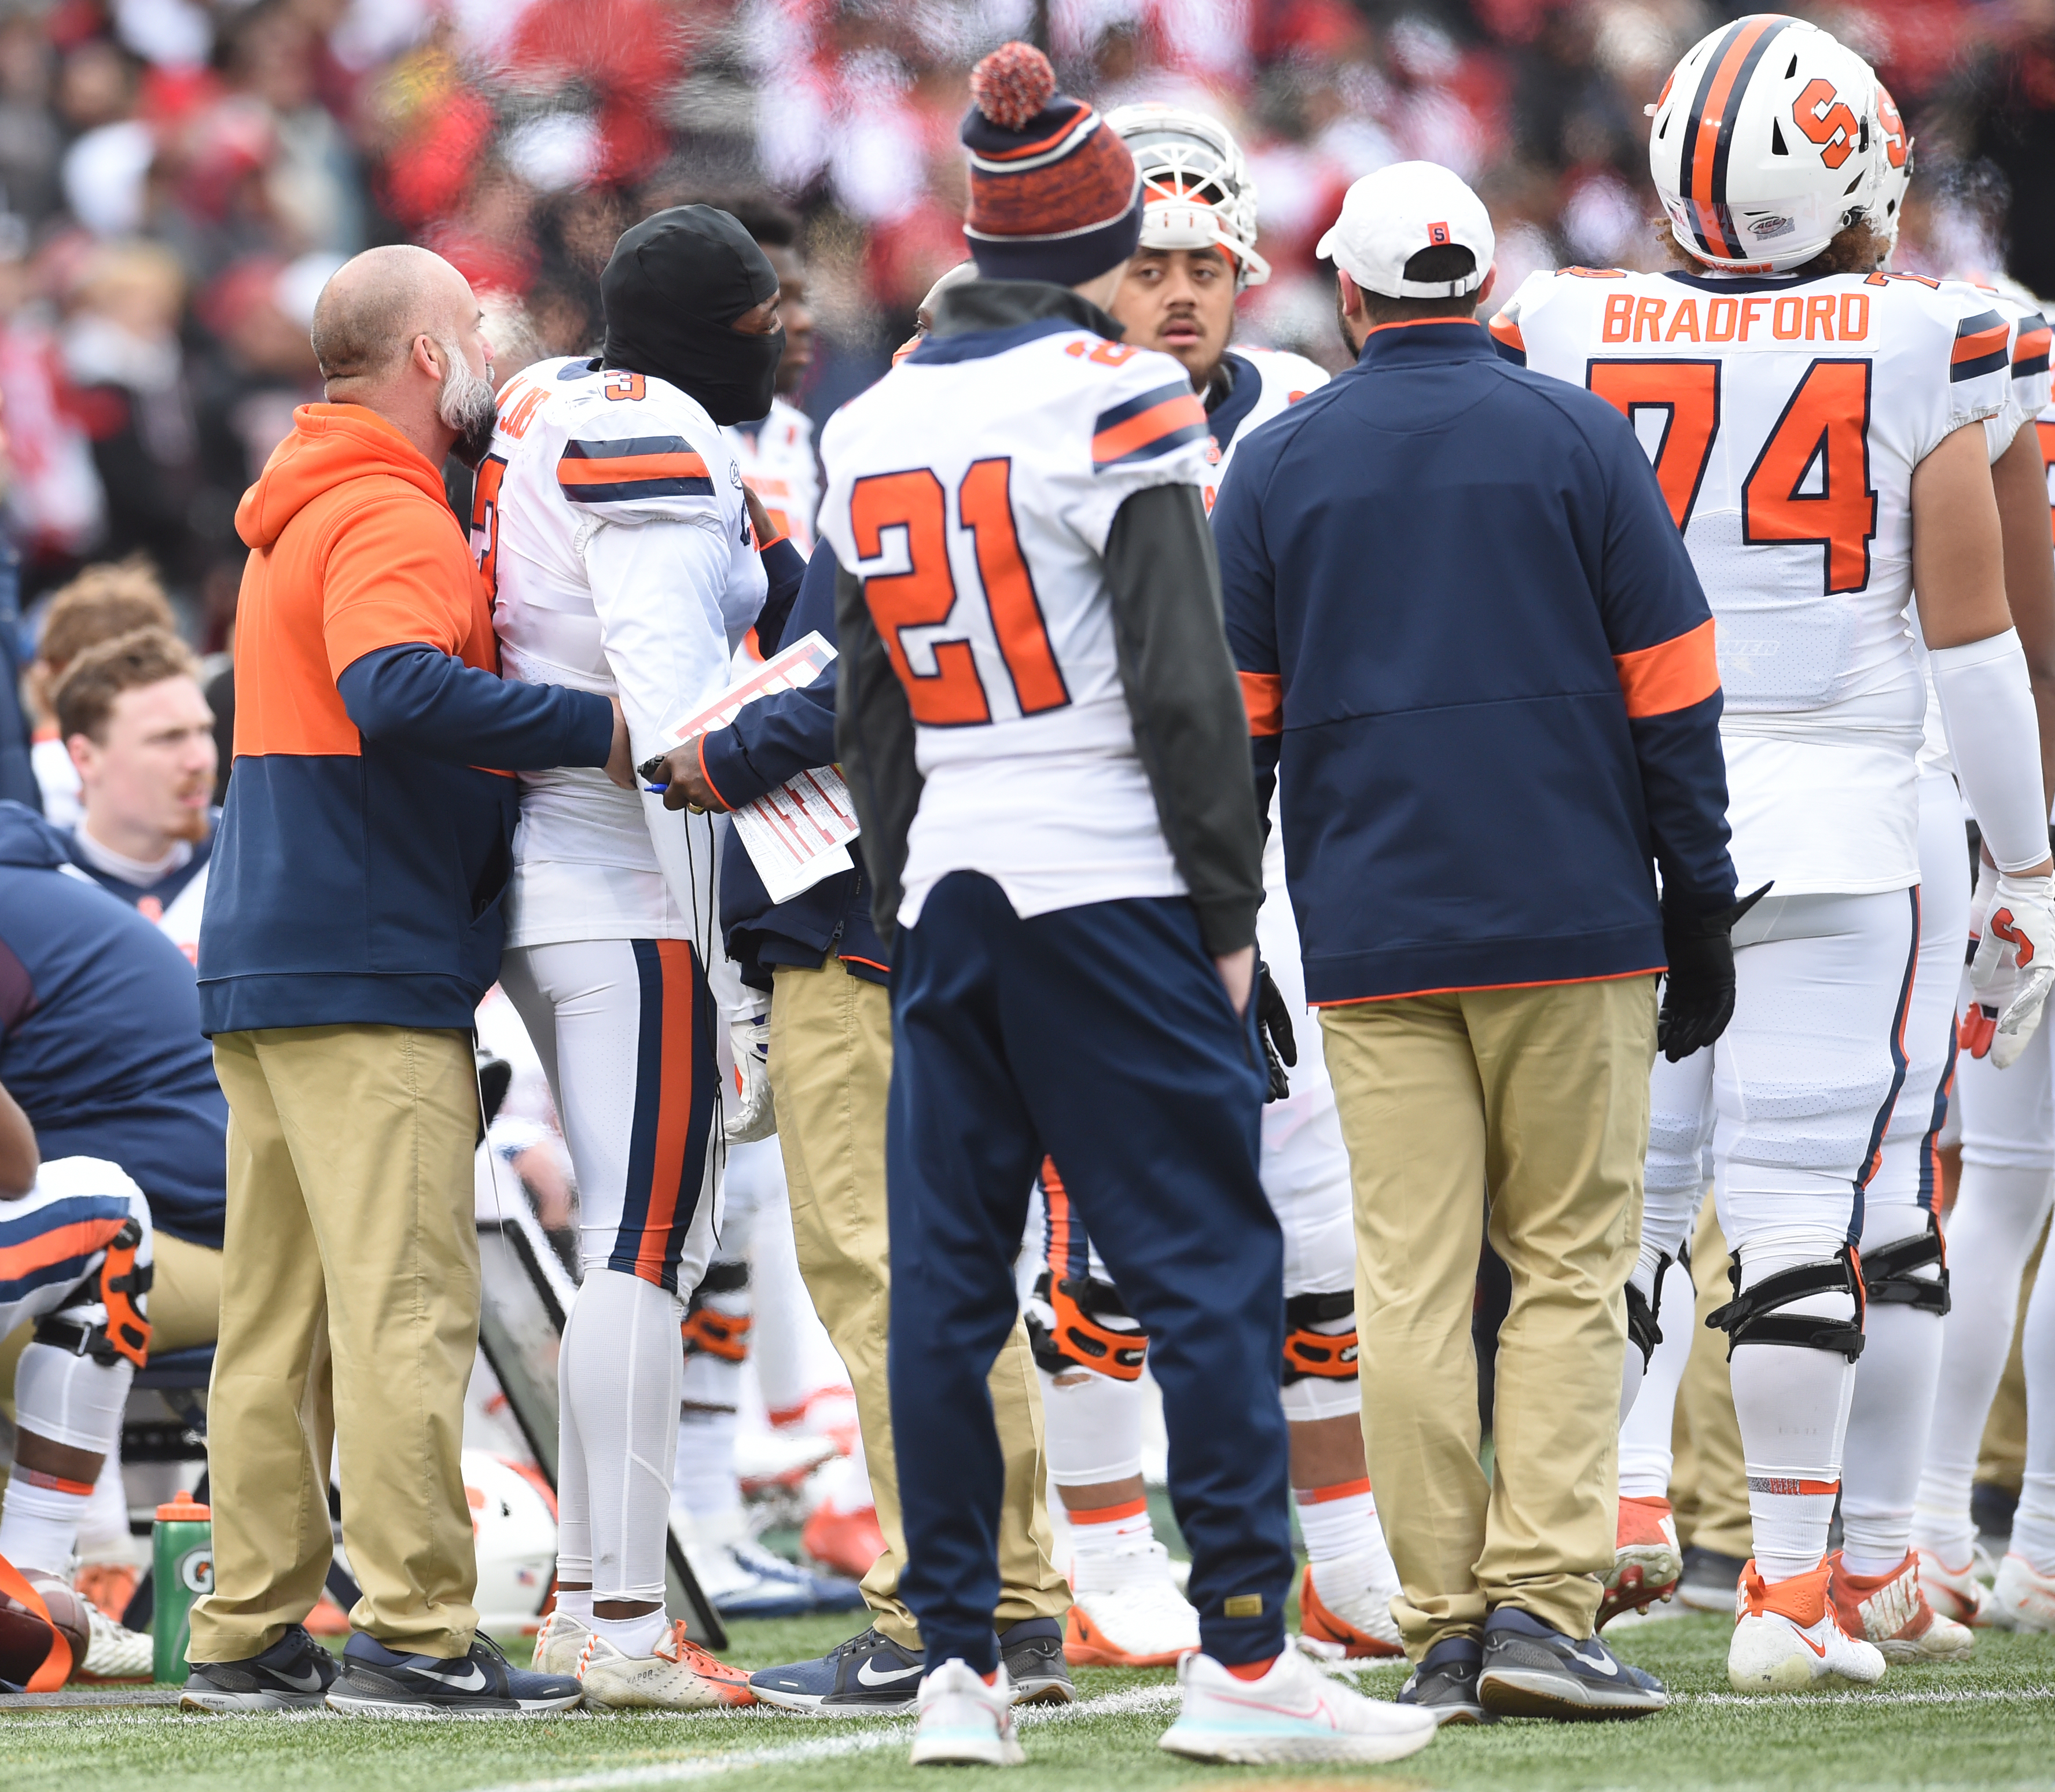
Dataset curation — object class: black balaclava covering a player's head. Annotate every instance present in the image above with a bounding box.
[600,205,785,424]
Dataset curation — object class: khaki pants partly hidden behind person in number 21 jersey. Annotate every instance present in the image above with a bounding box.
[771,955,1071,1648]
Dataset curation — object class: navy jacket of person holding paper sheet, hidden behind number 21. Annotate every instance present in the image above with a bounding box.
[699,543,890,988]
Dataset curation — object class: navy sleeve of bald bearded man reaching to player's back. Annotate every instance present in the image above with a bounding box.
[335,641,615,771]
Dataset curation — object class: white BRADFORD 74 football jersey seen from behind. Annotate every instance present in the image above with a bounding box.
[1490,267,2010,896]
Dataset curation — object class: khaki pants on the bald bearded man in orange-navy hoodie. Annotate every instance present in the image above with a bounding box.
[189,1025,479,1661]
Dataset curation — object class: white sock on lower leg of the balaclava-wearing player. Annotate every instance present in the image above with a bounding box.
[559,1270,684,1619]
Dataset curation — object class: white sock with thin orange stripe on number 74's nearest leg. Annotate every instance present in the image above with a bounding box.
[1728,1239,1856,1580]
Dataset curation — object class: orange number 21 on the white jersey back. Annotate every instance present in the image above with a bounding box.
[849,456,1071,727]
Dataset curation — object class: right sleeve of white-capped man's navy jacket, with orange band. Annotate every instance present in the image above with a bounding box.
[1586,407,1734,908]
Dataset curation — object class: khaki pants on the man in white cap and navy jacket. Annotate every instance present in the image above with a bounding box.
[1321,976,1656,1661]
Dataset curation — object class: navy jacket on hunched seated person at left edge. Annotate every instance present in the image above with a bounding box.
[0,801,228,1249]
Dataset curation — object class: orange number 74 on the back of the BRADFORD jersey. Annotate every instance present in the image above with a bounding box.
[1585,360,1876,596]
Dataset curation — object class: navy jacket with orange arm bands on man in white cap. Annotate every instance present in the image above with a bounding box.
[1212,321,1734,1005]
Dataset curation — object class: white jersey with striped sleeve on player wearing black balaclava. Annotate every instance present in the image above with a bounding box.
[470,355,764,945]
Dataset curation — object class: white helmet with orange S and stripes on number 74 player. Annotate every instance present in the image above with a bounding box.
[1648,12,1883,273]
